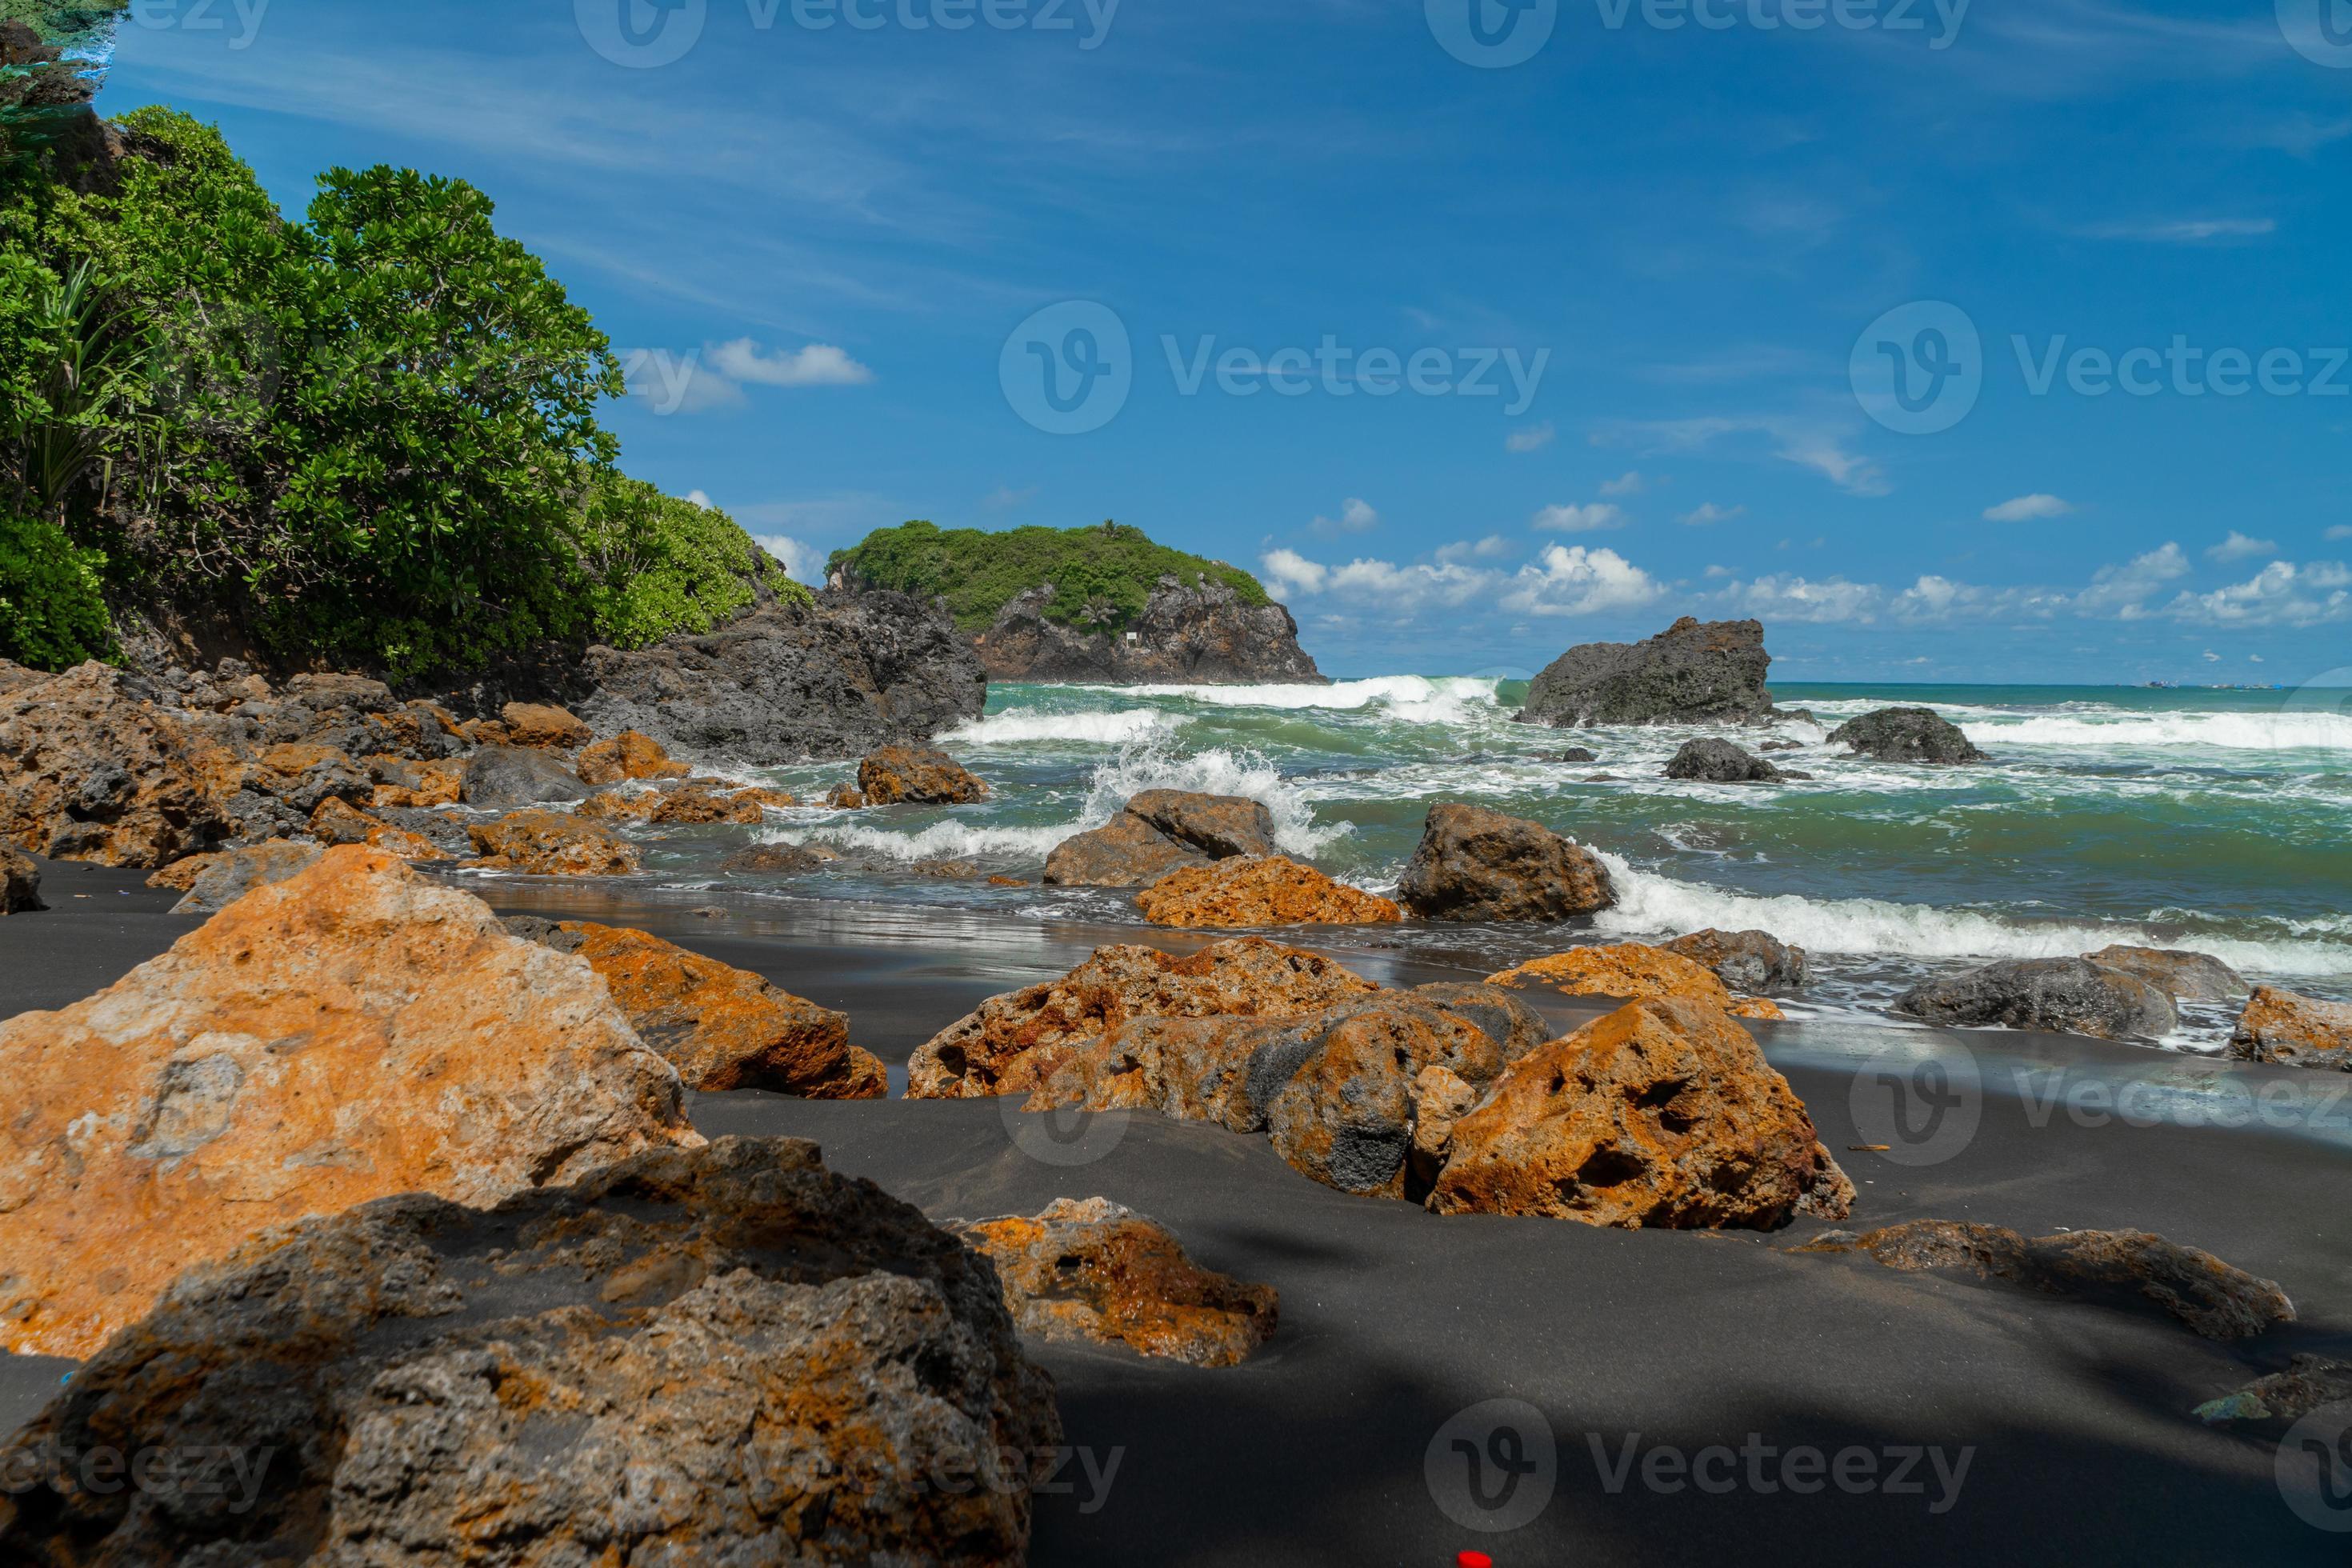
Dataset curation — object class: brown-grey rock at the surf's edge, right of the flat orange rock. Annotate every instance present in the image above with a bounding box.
[1397,804,1616,922]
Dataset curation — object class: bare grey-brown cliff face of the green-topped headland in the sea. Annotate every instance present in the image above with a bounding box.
[971,576,1324,686]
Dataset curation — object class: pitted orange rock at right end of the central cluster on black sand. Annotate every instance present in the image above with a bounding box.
[1430,1006,1854,1230]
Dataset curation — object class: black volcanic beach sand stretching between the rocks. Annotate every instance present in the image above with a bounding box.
[0,867,2352,1568]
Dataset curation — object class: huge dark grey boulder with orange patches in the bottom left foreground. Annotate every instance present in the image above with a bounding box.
[0,1142,1061,1568]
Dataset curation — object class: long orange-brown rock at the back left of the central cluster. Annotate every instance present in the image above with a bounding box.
[908,938,1378,1100]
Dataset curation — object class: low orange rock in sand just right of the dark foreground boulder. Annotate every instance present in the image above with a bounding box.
[950,1199,1282,1366]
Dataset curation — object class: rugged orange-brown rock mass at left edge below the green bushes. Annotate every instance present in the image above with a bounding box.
[0,663,240,870]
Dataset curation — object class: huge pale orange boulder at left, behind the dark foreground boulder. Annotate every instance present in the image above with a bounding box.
[0,849,698,1357]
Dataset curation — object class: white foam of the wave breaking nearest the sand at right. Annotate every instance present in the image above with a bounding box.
[1594,851,2352,975]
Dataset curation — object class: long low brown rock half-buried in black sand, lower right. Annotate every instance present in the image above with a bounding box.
[1797,1220,2295,1340]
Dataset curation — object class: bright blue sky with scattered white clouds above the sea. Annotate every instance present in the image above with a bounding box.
[101,0,2352,686]
